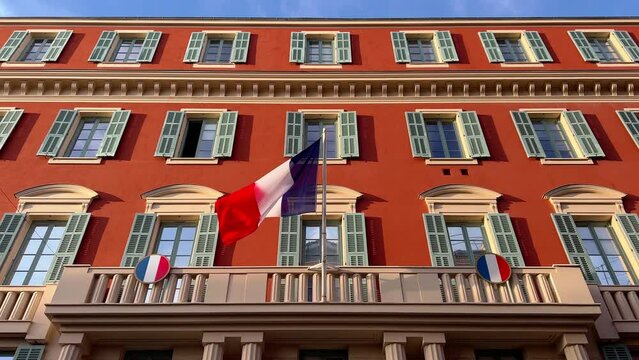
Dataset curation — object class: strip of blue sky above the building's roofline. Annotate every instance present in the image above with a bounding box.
[0,0,639,17]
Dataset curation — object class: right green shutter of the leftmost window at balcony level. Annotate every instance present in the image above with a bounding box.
[47,213,91,283]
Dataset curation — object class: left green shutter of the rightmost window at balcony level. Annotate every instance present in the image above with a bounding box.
[552,213,599,283]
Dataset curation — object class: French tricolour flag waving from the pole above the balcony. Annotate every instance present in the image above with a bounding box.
[215,140,320,245]
